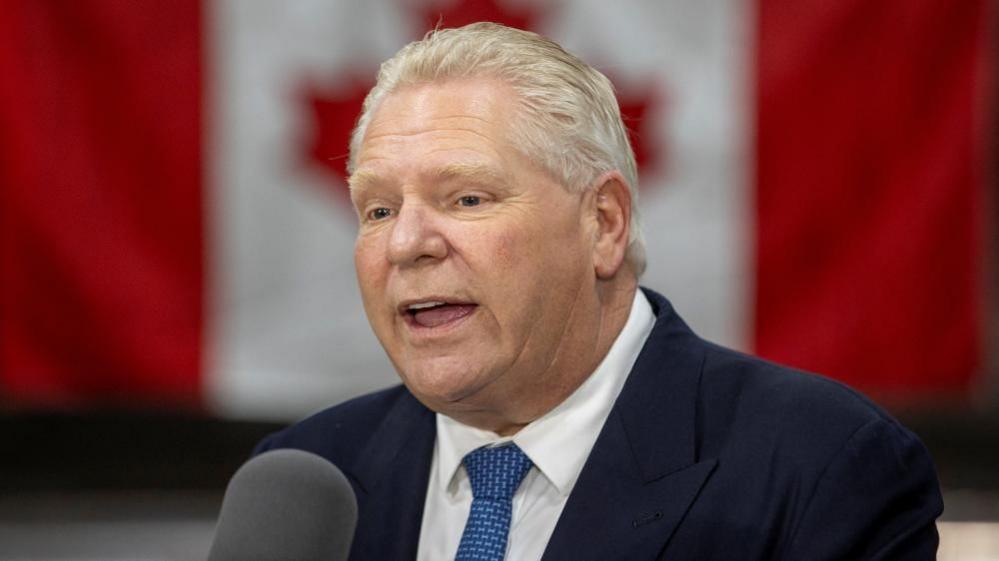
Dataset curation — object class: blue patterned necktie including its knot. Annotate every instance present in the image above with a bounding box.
[454,444,531,561]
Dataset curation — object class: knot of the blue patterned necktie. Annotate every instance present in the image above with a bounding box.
[463,443,532,501]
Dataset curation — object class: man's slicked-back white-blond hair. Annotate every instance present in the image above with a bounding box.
[347,22,645,275]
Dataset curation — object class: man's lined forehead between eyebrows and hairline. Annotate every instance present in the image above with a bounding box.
[355,78,516,177]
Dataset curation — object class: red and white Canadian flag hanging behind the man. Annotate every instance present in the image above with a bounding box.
[0,0,995,418]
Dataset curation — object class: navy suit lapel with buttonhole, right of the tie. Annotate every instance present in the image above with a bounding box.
[542,291,717,561]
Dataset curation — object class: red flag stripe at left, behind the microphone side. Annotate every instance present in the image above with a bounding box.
[0,0,204,405]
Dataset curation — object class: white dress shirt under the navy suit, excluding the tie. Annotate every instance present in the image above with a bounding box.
[417,290,655,561]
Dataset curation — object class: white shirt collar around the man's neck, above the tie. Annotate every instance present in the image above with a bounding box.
[437,290,655,496]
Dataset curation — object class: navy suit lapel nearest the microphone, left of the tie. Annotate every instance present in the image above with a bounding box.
[350,392,436,561]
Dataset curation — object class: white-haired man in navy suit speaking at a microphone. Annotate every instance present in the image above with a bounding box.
[258,24,942,561]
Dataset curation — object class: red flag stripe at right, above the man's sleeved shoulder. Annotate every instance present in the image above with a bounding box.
[753,0,988,397]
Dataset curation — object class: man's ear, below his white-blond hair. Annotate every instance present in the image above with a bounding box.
[593,170,631,280]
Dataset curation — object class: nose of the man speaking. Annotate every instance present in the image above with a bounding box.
[388,201,448,266]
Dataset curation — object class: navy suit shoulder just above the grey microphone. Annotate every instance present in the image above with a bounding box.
[253,385,412,463]
